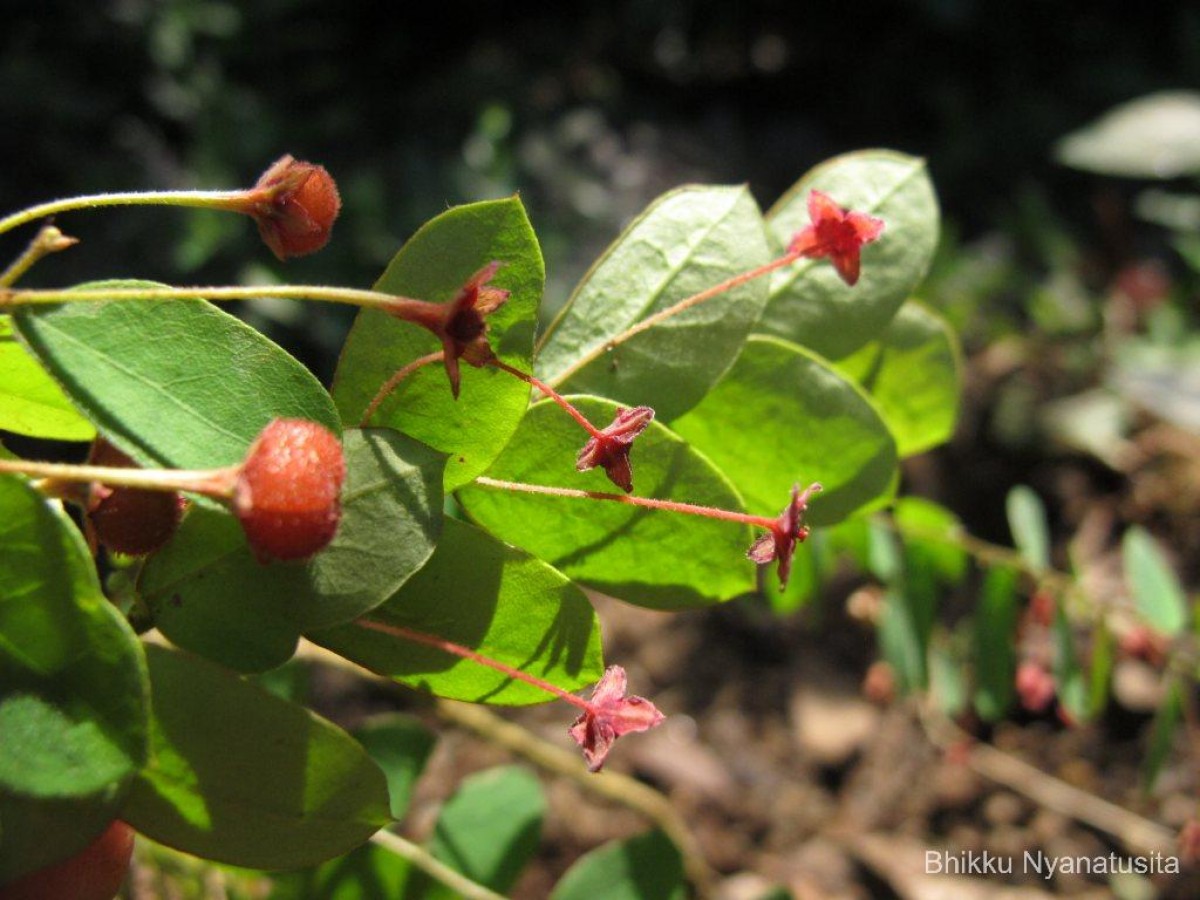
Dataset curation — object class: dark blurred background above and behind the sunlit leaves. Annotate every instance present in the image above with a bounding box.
[0,0,1200,542]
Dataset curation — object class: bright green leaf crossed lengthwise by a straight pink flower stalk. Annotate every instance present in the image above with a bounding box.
[460,397,748,610]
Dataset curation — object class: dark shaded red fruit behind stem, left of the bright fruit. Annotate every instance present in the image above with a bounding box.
[88,439,184,556]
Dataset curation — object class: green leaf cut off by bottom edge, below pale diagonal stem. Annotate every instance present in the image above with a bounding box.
[268,844,414,900]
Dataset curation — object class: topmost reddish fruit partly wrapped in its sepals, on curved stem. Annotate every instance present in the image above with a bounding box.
[245,156,342,259]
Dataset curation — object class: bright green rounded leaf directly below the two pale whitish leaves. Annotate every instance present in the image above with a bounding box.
[673,337,896,524]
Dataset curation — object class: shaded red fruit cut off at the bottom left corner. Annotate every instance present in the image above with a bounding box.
[0,820,133,900]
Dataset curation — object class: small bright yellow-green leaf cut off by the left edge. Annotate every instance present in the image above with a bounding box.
[0,316,96,440]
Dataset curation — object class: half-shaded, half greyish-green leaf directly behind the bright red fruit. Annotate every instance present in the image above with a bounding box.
[139,428,444,672]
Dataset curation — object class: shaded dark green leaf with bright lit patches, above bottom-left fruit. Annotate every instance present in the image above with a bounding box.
[121,646,390,869]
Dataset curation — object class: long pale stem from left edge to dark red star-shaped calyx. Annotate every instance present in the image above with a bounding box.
[0,284,442,324]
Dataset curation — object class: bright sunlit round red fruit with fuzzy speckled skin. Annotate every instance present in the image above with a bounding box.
[233,419,346,563]
